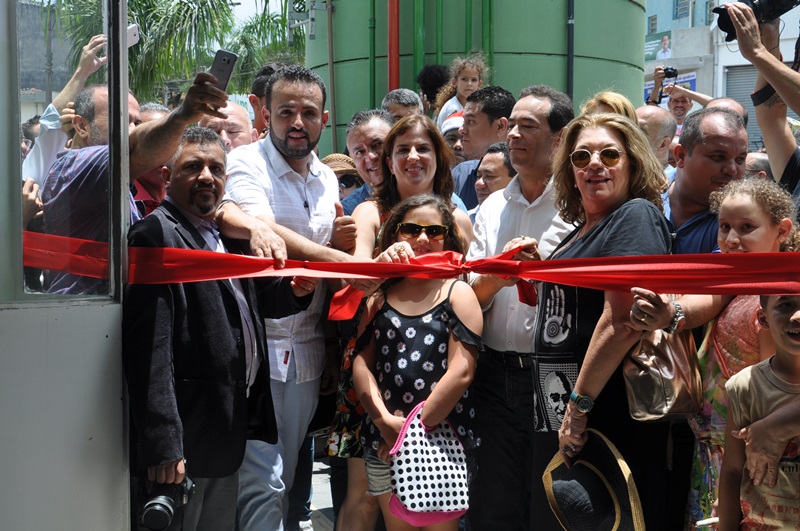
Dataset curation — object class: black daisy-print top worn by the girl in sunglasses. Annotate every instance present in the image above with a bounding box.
[361,282,483,454]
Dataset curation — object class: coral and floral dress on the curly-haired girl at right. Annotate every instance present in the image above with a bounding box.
[687,295,761,529]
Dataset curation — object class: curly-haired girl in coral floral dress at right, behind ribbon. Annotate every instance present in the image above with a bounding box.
[630,178,800,529]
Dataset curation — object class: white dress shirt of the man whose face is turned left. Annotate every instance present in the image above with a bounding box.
[467,176,575,352]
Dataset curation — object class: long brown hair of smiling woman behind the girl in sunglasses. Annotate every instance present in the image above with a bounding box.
[374,114,455,213]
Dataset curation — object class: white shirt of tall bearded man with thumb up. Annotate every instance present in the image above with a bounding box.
[225,135,339,383]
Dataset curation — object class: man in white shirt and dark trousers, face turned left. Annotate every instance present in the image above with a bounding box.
[467,85,574,530]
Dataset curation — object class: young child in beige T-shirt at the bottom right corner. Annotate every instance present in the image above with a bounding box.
[719,295,800,531]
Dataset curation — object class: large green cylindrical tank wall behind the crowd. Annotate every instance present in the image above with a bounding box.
[306,0,645,155]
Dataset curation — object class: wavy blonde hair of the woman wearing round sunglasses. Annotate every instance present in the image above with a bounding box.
[553,113,667,223]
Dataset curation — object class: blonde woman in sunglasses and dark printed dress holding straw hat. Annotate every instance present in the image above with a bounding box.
[533,113,670,529]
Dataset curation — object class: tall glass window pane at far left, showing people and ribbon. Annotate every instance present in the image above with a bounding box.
[11,0,127,302]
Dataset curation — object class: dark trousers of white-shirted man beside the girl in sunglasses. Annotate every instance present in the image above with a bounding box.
[467,353,545,531]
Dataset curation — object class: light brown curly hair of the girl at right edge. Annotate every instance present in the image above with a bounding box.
[709,178,800,252]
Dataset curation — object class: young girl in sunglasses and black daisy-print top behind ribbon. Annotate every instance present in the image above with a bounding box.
[353,194,483,531]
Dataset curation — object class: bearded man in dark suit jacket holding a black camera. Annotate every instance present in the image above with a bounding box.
[123,127,319,531]
